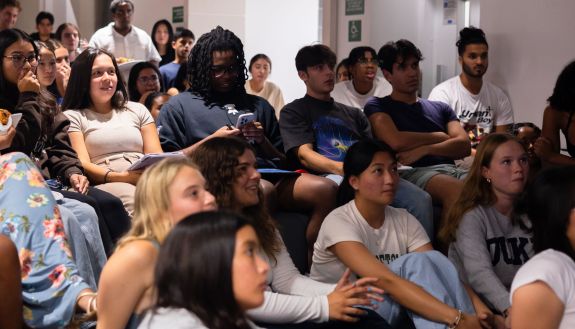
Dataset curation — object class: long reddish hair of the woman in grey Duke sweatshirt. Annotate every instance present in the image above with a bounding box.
[438,133,525,244]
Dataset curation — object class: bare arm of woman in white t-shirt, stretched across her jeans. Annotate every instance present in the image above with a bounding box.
[329,241,479,328]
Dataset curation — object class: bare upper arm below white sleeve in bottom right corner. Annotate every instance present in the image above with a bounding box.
[511,281,565,329]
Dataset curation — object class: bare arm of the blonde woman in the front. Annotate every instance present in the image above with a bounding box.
[97,240,158,329]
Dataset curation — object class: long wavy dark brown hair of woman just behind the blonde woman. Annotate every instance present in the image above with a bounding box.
[191,137,280,260]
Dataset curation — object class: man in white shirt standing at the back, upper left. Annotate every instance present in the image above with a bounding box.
[89,0,162,65]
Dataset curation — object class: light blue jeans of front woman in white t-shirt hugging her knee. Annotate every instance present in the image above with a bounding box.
[377,251,475,329]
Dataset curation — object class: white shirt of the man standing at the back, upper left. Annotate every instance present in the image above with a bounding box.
[89,22,162,63]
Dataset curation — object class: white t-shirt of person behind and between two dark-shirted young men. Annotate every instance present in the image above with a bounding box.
[331,76,391,110]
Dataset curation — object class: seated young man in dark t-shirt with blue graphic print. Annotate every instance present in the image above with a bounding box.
[280,45,433,236]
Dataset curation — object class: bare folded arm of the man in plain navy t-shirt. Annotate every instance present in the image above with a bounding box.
[369,113,449,152]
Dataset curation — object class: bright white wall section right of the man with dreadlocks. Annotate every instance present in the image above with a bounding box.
[243,0,319,103]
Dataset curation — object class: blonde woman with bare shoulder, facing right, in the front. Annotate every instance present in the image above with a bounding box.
[98,158,216,329]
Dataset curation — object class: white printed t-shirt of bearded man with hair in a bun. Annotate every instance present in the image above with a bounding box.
[429,76,513,144]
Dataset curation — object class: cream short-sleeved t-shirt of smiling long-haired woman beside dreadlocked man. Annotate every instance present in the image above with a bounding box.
[64,102,154,163]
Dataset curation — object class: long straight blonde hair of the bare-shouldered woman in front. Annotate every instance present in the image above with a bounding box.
[118,157,201,248]
